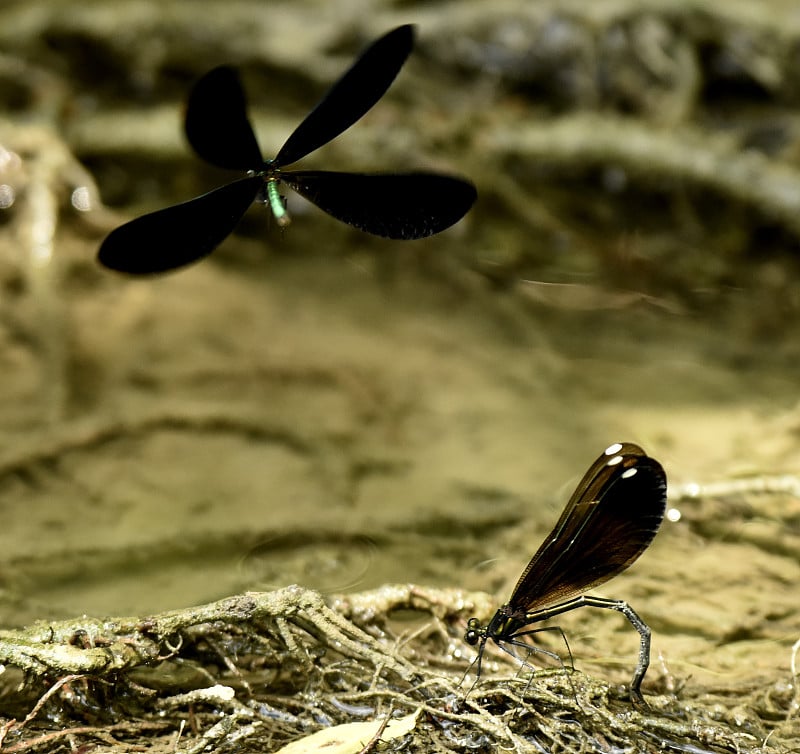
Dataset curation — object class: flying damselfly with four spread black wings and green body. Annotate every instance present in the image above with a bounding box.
[98,25,477,274]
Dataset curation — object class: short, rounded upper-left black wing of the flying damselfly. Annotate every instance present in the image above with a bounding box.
[184,66,263,171]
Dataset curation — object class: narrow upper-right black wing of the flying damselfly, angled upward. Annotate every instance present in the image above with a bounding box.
[272,25,414,167]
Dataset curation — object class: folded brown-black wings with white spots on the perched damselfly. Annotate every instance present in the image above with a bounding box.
[509,443,667,614]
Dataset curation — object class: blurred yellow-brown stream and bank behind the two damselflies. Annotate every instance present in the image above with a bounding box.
[0,0,800,716]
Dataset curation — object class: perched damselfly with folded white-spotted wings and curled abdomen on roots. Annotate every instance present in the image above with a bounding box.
[464,443,667,705]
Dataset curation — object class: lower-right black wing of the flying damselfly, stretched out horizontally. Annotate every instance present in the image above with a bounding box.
[281,170,477,240]
